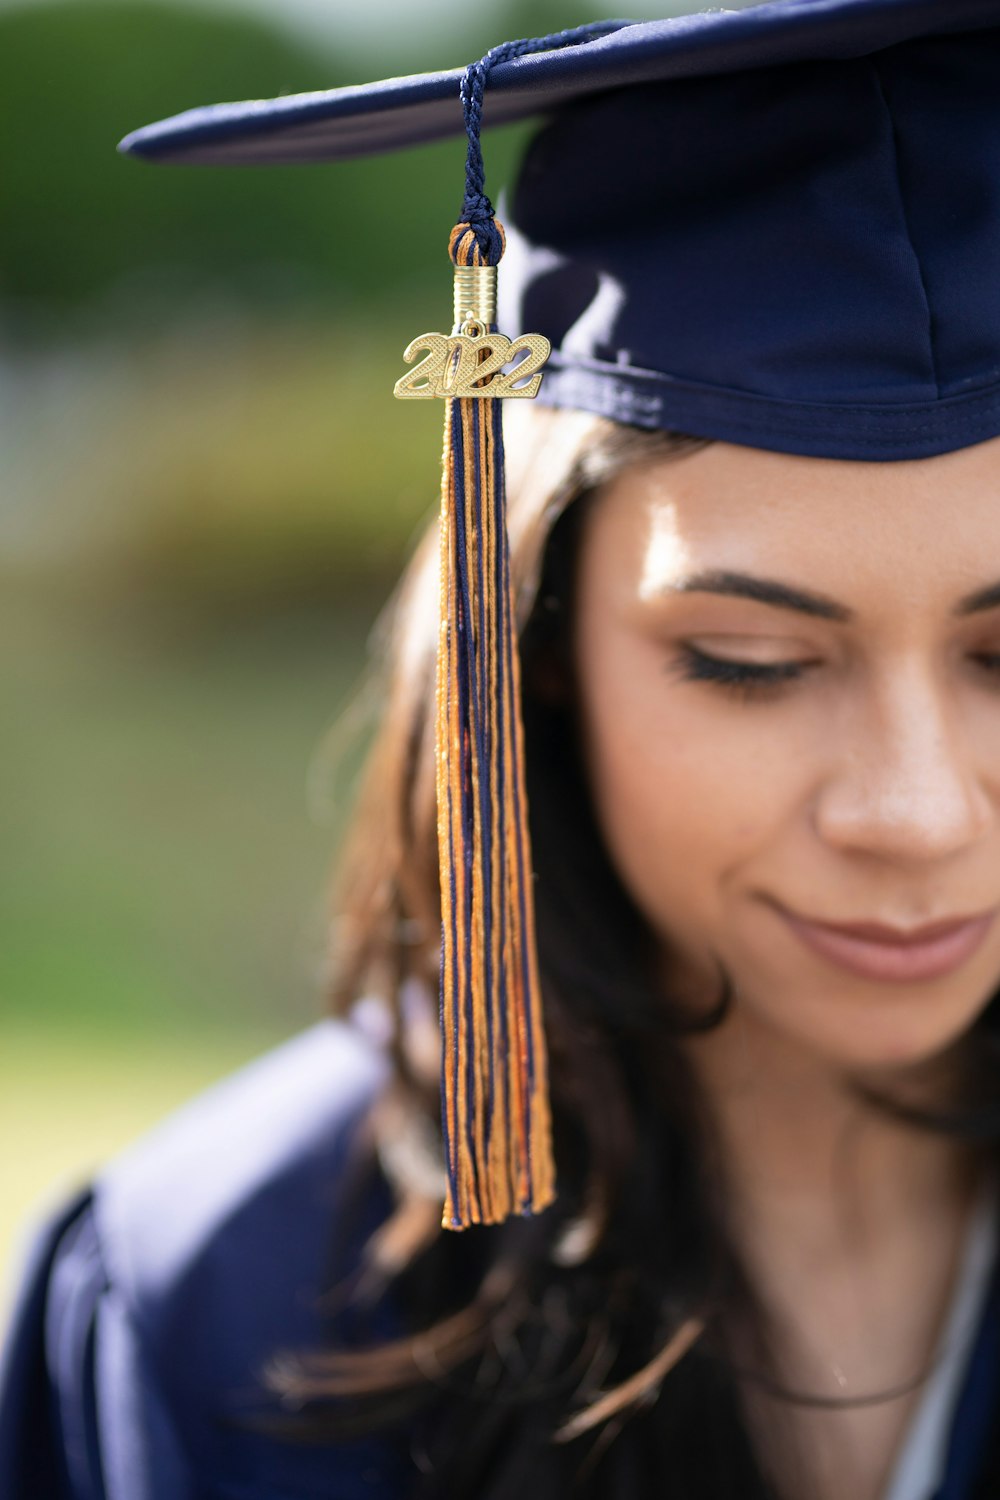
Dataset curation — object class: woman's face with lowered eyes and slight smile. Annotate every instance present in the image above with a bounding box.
[574,438,1000,1068]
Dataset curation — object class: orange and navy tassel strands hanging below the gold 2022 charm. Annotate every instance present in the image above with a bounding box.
[436,224,555,1229]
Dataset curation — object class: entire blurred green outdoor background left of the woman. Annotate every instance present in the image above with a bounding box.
[0,0,734,1290]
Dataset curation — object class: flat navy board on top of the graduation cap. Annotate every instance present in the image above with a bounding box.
[118,0,1000,165]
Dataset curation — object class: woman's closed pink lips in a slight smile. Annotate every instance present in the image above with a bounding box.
[778,906,996,983]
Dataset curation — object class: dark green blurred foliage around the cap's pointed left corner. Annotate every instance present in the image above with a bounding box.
[0,0,542,332]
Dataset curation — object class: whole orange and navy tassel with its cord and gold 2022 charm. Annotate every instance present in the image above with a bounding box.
[394,23,621,1229]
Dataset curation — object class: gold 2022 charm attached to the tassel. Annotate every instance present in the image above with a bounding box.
[393,320,552,401]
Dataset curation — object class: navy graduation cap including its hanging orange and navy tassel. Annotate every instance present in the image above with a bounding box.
[121,0,1000,1229]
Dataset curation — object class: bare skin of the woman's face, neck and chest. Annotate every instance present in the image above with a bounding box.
[573,438,1000,1500]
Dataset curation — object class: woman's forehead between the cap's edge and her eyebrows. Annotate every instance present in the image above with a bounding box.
[589,438,1000,600]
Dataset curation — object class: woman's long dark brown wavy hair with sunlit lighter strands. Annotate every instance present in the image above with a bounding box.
[262,404,996,1500]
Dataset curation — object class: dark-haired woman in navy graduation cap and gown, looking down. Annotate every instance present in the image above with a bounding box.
[0,0,1000,1500]
